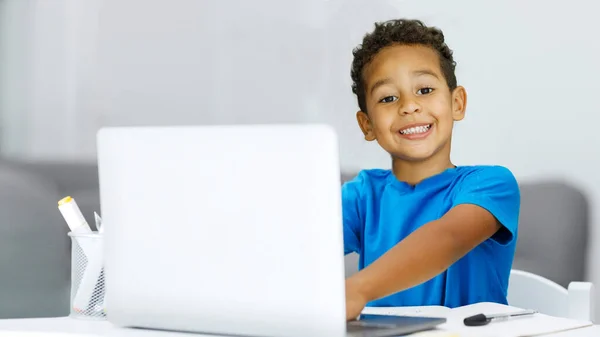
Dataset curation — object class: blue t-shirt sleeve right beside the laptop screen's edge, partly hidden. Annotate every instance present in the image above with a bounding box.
[342,176,363,255]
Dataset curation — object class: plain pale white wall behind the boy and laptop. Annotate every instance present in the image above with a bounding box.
[2,0,600,320]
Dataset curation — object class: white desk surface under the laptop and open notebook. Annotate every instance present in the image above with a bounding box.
[0,317,600,337]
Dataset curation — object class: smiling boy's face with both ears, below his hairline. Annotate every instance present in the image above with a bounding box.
[357,45,466,161]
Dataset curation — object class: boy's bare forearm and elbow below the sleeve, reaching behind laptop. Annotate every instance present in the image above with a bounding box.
[346,204,501,304]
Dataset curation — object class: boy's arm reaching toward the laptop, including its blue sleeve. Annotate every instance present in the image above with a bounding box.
[346,166,520,319]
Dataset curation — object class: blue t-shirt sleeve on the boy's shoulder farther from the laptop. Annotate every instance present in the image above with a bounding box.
[453,166,521,245]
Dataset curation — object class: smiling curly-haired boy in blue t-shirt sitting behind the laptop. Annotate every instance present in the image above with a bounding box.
[342,20,520,319]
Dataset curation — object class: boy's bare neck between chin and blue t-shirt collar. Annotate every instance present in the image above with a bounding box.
[392,157,455,185]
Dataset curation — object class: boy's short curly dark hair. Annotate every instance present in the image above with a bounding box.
[350,19,456,113]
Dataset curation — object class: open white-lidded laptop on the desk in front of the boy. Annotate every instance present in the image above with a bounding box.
[97,125,445,337]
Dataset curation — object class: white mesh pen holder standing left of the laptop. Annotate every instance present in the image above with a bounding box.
[69,232,106,320]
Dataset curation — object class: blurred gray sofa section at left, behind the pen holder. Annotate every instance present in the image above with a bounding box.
[0,160,100,318]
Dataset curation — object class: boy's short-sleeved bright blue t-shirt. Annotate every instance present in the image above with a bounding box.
[342,166,521,308]
